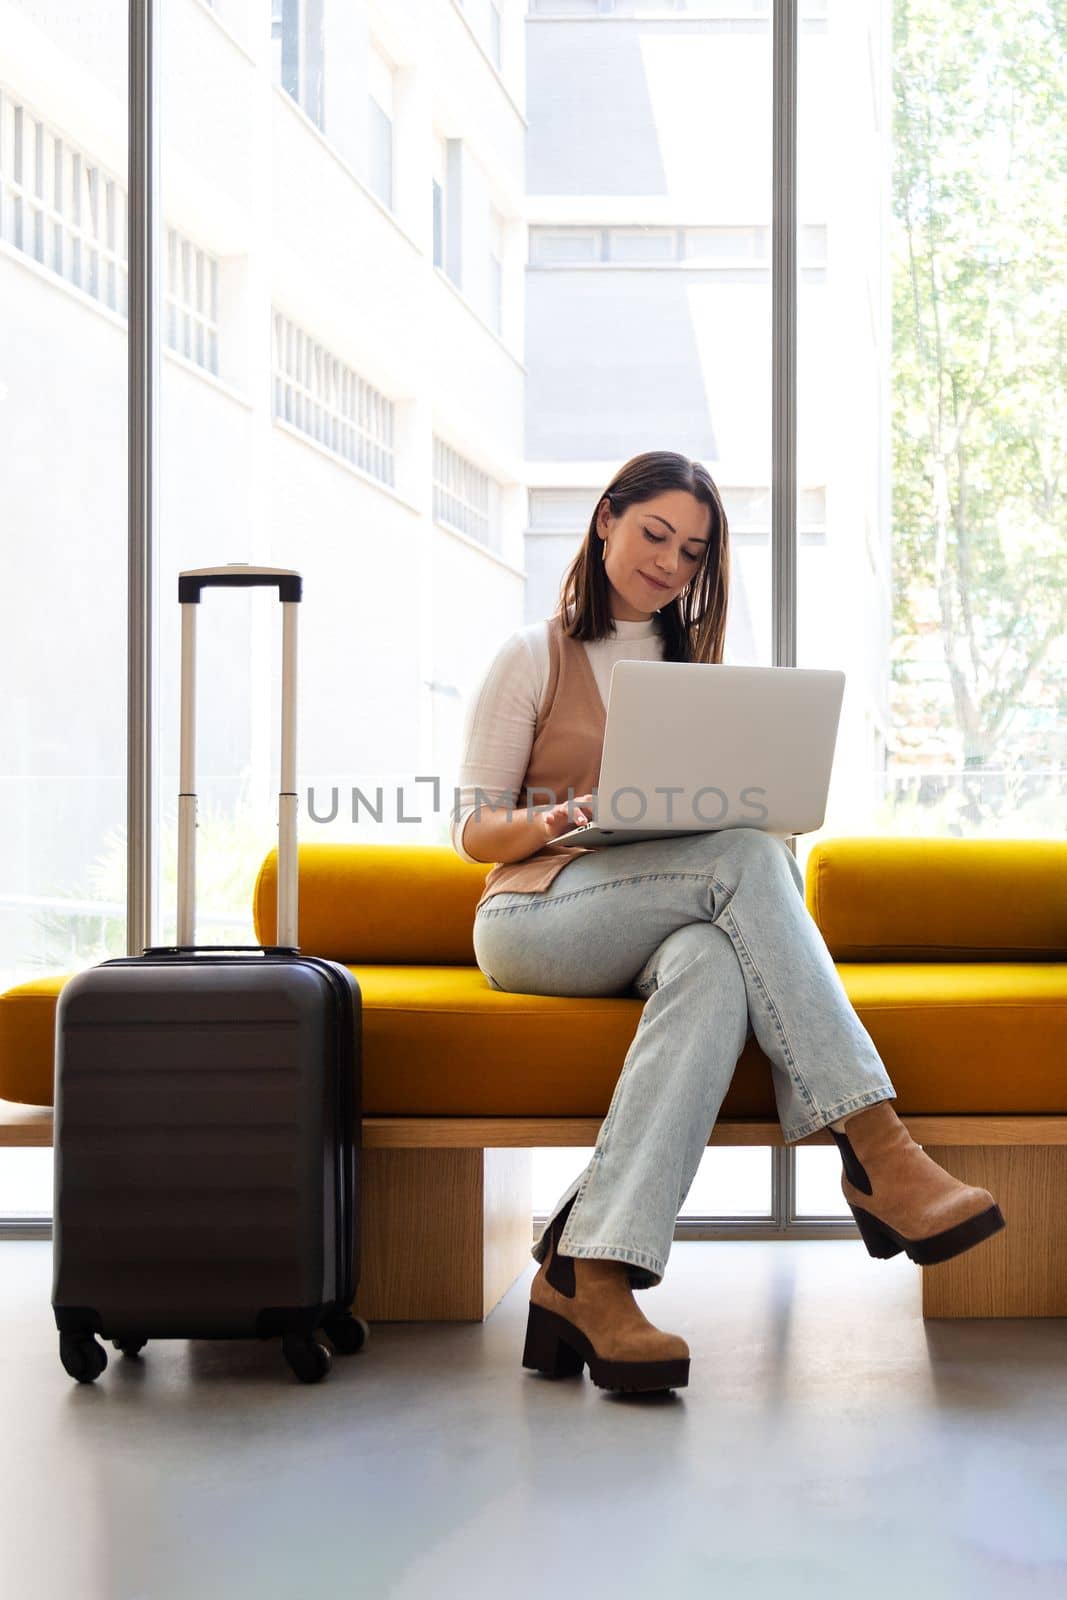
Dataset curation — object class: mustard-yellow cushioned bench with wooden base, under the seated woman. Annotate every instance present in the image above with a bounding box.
[0,838,1067,1320]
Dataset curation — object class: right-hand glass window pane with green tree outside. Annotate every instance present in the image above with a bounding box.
[797,0,1067,858]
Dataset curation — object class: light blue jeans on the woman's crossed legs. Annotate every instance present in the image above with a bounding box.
[474,827,896,1290]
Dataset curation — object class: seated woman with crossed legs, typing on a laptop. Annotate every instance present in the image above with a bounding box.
[453,451,1005,1389]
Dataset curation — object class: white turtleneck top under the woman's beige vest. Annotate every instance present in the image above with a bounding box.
[450,618,662,861]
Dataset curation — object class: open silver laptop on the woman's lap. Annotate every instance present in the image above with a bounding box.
[552,661,845,846]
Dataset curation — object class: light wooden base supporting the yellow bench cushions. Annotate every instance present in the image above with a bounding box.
[0,1102,1067,1322]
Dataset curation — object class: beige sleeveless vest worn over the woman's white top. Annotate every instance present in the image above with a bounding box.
[478,616,608,907]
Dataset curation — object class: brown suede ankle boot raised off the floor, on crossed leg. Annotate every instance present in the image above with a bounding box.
[830,1101,1005,1267]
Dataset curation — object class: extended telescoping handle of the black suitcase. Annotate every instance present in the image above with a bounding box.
[178,562,302,952]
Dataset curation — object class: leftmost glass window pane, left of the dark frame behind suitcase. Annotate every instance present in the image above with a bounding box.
[0,6,127,1221]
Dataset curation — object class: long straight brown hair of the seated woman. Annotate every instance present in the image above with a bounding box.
[557,450,729,662]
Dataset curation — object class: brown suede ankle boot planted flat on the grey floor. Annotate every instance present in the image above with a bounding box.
[523,1200,689,1390]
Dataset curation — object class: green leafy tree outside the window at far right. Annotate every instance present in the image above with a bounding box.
[893,0,1067,766]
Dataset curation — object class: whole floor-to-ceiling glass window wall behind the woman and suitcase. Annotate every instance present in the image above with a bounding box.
[8,0,1043,1235]
